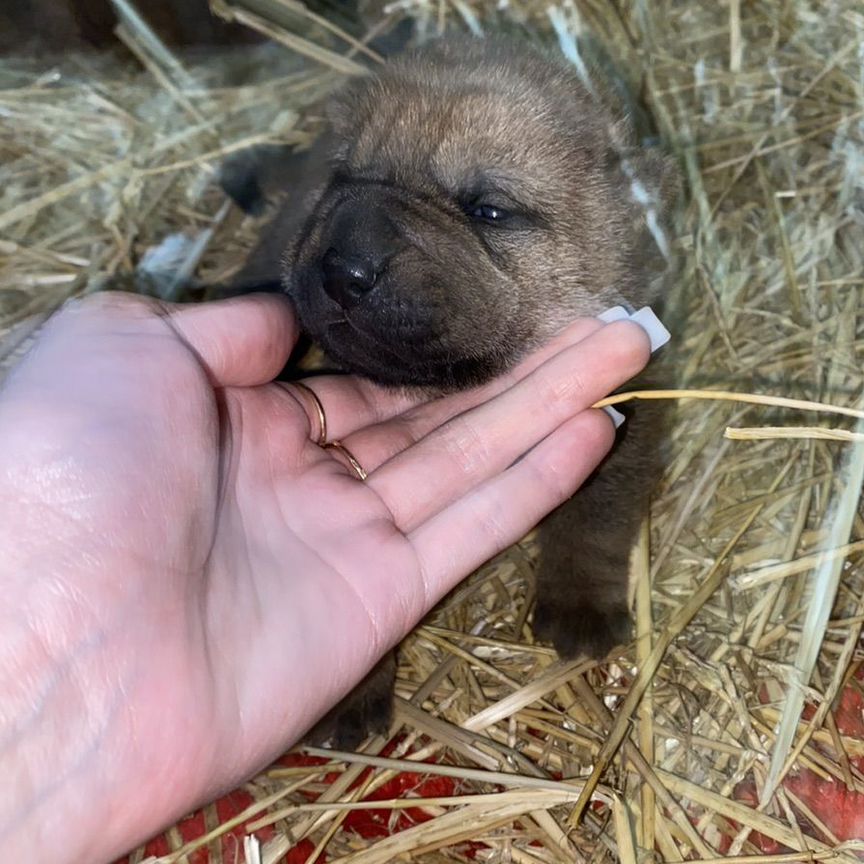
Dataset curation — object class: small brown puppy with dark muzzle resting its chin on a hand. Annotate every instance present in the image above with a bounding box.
[226,39,677,747]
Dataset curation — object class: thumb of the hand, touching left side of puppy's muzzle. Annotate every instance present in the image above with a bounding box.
[163,294,298,387]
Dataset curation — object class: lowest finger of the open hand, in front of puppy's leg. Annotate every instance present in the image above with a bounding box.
[408,410,614,618]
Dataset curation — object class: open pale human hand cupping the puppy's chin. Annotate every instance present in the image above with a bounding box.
[0,294,649,864]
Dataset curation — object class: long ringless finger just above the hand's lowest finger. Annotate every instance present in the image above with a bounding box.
[364,322,651,532]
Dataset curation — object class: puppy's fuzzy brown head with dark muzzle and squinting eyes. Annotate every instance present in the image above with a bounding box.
[285,40,672,390]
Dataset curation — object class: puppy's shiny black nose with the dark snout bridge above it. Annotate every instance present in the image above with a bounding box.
[320,197,398,309]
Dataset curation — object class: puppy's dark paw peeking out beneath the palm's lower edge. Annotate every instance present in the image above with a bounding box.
[305,651,396,750]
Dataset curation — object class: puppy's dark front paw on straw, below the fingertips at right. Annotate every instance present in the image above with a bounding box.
[534,598,632,660]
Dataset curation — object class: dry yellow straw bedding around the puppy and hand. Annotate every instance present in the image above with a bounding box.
[0,0,864,864]
